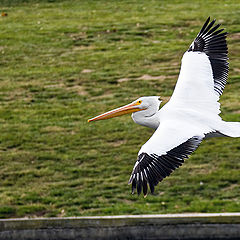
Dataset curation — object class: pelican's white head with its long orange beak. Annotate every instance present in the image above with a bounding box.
[88,96,162,128]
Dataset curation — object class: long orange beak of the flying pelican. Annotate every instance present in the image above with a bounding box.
[88,102,145,122]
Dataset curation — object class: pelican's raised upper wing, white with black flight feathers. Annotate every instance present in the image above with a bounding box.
[170,18,229,114]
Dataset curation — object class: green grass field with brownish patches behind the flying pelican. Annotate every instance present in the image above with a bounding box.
[0,0,240,218]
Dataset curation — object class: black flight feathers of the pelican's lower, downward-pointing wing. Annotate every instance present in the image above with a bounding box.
[128,136,203,197]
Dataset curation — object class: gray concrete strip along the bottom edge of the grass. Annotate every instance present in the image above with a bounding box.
[0,213,240,240]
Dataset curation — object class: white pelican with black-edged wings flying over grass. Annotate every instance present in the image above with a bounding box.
[88,17,240,197]
